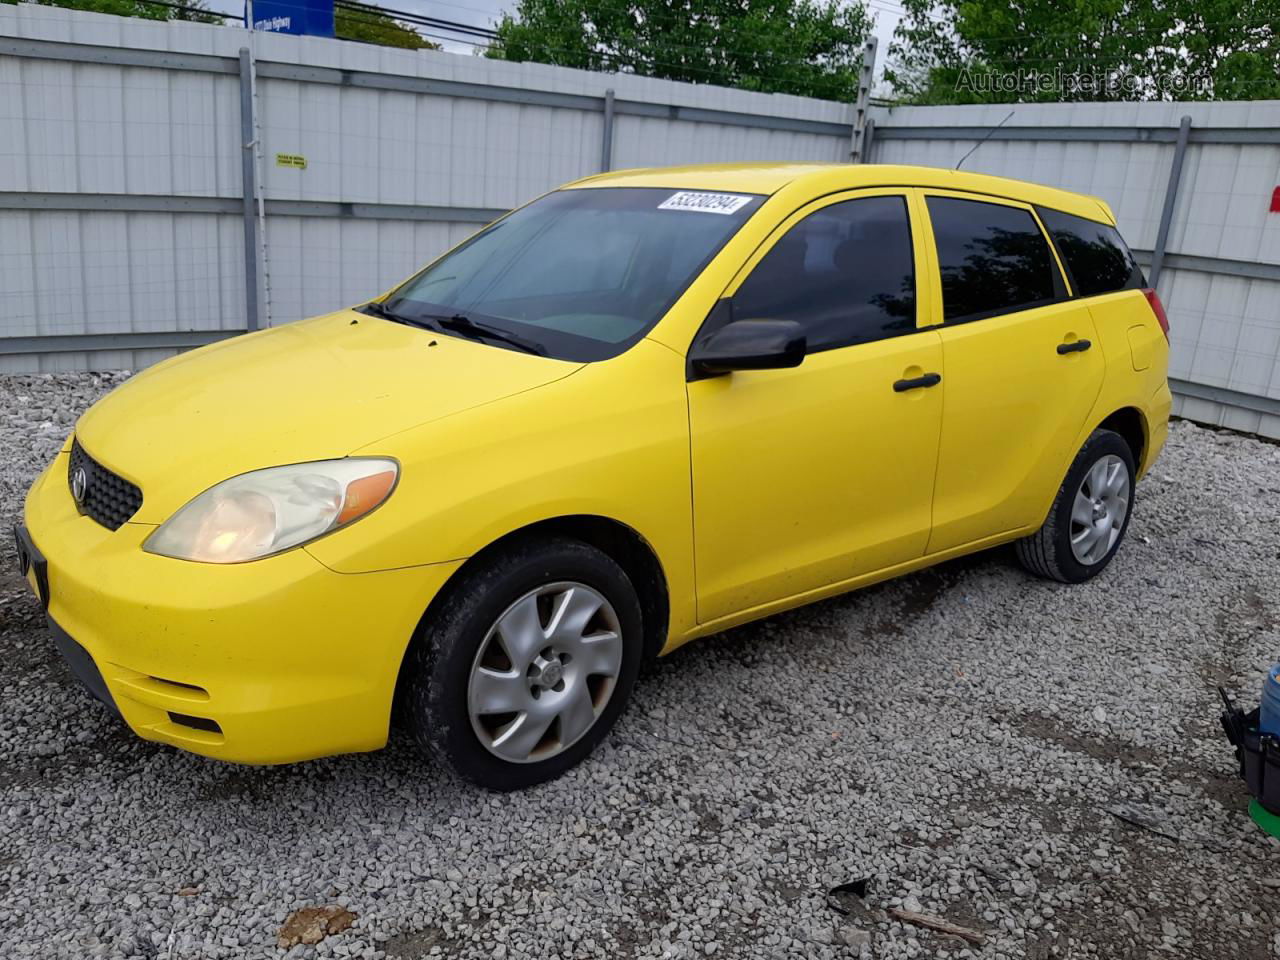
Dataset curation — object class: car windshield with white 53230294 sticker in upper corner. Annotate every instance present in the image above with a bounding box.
[384,187,763,361]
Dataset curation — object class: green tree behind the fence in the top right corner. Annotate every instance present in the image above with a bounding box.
[884,0,1280,104]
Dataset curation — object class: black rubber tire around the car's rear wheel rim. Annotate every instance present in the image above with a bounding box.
[1014,430,1137,584]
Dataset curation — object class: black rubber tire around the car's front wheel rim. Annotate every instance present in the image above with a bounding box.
[402,539,644,791]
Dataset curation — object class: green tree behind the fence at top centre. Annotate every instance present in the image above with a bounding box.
[486,0,872,100]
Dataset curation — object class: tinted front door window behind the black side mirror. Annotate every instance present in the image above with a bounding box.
[733,197,915,351]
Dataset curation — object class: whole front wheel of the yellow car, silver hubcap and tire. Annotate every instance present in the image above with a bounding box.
[404,539,644,790]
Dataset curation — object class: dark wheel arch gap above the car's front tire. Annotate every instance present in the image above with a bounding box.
[396,513,671,721]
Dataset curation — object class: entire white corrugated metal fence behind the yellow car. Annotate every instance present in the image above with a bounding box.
[0,4,1280,436]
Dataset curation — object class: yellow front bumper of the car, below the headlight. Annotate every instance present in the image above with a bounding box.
[24,453,458,763]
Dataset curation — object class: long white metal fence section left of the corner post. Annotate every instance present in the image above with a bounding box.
[0,4,854,371]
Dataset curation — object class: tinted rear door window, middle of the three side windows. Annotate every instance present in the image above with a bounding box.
[928,197,1062,323]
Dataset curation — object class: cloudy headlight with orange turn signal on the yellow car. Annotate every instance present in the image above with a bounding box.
[142,457,399,563]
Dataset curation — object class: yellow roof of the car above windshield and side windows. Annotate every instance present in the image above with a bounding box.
[568,164,1115,224]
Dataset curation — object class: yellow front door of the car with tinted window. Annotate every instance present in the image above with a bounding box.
[689,191,942,623]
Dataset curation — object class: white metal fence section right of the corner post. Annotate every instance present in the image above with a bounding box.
[867,101,1280,438]
